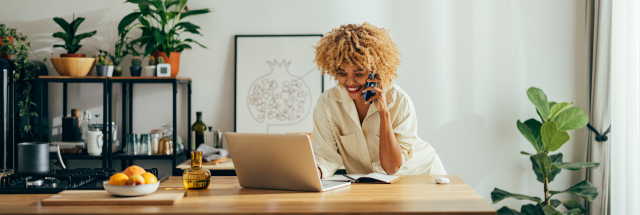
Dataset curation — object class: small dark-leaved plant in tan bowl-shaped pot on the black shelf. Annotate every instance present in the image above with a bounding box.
[51,15,97,76]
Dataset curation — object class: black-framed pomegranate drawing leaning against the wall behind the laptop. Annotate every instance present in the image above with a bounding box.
[234,34,325,134]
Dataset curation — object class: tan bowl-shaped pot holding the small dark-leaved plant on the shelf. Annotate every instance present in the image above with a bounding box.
[51,57,96,76]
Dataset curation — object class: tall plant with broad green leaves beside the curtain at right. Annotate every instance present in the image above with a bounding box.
[491,87,600,215]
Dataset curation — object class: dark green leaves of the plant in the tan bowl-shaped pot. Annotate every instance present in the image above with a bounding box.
[53,15,97,54]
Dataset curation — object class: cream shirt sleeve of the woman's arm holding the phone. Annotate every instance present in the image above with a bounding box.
[393,97,418,165]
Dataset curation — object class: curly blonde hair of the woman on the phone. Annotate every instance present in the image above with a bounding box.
[314,22,400,88]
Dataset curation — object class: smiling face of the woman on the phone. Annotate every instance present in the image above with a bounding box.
[338,64,369,100]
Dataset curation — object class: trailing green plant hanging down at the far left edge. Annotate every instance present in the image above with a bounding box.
[0,23,47,141]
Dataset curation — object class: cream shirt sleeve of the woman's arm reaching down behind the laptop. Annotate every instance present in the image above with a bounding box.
[312,97,343,178]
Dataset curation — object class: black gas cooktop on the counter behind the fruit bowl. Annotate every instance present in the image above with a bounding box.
[0,168,169,194]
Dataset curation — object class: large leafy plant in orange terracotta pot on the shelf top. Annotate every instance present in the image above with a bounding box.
[118,0,211,77]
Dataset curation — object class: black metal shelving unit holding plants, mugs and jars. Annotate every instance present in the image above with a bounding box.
[37,76,191,175]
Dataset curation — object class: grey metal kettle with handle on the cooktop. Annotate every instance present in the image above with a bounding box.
[17,143,66,175]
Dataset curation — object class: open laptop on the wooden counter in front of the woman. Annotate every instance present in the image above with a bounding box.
[225,132,351,192]
